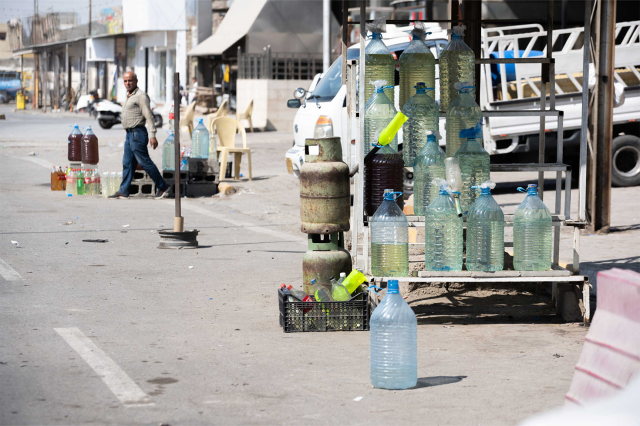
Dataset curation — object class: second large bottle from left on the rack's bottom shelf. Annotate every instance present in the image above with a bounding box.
[424,179,462,271]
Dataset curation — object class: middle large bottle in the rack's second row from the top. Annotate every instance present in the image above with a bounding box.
[402,82,439,167]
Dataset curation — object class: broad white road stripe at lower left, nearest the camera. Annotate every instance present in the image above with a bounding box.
[54,327,155,407]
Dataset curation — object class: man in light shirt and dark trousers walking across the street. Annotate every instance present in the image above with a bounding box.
[109,71,172,199]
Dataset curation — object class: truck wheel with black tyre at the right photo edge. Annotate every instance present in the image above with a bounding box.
[611,135,640,186]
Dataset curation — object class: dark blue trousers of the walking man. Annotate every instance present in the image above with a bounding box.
[120,126,169,196]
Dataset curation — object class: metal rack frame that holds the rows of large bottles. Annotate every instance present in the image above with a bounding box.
[343,0,592,322]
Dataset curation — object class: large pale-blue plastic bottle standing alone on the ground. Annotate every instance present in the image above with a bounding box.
[369,280,418,389]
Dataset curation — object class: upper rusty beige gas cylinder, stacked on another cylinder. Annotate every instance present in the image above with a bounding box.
[300,138,351,234]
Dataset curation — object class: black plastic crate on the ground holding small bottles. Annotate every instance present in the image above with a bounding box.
[278,289,369,333]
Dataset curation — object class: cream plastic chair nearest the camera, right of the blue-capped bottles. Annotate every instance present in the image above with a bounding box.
[211,117,253,181]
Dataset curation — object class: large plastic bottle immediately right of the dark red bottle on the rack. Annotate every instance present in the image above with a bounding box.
[413,132,445,216]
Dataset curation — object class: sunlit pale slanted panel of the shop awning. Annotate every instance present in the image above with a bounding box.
[188,0,267,56]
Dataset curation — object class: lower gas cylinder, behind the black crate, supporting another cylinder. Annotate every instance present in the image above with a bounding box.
[302,232,352,294]
